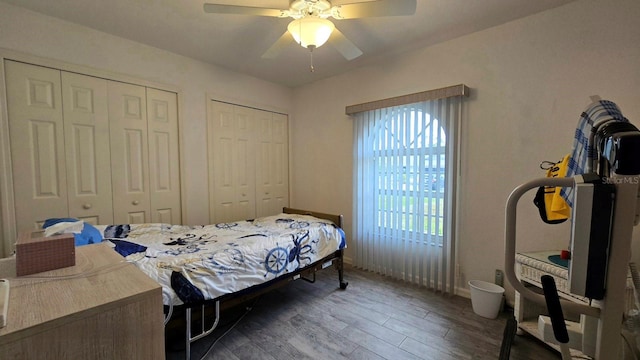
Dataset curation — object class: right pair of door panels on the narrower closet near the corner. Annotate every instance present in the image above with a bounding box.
[256,111,289,217]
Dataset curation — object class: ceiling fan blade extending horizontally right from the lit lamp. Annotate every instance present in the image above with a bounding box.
[332,0,416,19]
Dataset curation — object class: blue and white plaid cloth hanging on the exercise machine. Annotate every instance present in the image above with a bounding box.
[560,100,629,207]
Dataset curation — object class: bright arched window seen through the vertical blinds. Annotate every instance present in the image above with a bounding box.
[372,111,446,245]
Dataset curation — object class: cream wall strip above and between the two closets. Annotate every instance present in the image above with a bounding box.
[0,2,292,231]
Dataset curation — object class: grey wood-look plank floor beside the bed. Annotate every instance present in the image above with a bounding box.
[167,268,561,360]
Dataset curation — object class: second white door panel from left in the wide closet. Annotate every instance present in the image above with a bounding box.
[62,71,113,224]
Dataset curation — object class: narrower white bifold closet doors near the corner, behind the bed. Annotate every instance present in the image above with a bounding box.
[208,101,289,223]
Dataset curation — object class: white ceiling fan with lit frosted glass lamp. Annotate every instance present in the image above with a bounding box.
[204,0,416,65]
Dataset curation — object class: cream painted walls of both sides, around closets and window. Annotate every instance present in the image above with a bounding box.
[0,0,640,304]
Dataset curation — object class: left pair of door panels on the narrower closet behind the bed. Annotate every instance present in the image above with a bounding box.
[208,101,256,223]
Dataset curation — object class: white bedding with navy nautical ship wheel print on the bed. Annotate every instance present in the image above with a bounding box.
[95,214,346,305]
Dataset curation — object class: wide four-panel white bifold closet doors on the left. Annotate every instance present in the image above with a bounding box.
[5,60,181,231]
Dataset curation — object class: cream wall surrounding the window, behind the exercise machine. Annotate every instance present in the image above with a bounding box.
[291,0,640,298]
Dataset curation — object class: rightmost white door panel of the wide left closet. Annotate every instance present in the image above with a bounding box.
[147,88,182,224]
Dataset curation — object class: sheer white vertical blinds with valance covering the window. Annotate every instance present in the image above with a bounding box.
[347,85,468,293]
